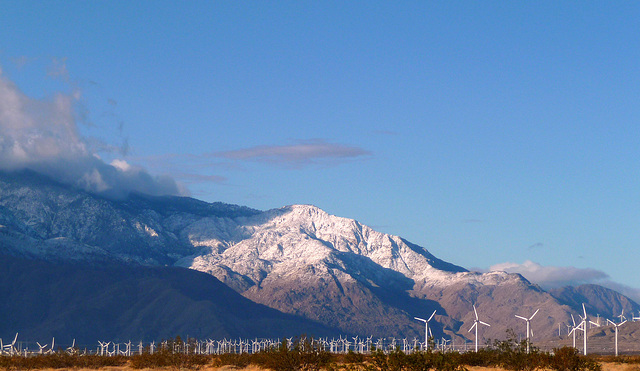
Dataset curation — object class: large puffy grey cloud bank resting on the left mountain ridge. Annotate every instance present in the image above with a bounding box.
[0,69,186,198]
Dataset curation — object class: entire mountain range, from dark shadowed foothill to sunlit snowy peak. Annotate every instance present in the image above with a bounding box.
[0,170,640,348]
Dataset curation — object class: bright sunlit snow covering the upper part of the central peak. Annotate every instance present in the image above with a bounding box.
[177,205,466,290]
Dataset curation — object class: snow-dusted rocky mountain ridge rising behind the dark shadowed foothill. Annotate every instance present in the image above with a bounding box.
[0,172,632,344]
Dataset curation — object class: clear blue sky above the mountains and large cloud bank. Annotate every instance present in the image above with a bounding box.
[0,1,640,299]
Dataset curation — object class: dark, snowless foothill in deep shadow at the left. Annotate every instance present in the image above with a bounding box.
[0,255,340,347]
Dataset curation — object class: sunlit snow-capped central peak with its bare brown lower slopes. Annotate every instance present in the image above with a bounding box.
[176,205,568,337]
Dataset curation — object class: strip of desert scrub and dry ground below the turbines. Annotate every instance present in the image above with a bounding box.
[0,337,640,371]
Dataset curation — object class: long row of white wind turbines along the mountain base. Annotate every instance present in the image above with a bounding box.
[0,305,640,357]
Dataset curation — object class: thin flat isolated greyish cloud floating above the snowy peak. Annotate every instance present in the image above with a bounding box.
[212,140,371,167]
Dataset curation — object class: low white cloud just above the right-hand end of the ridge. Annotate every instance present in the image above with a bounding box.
[489,260,609,288]
